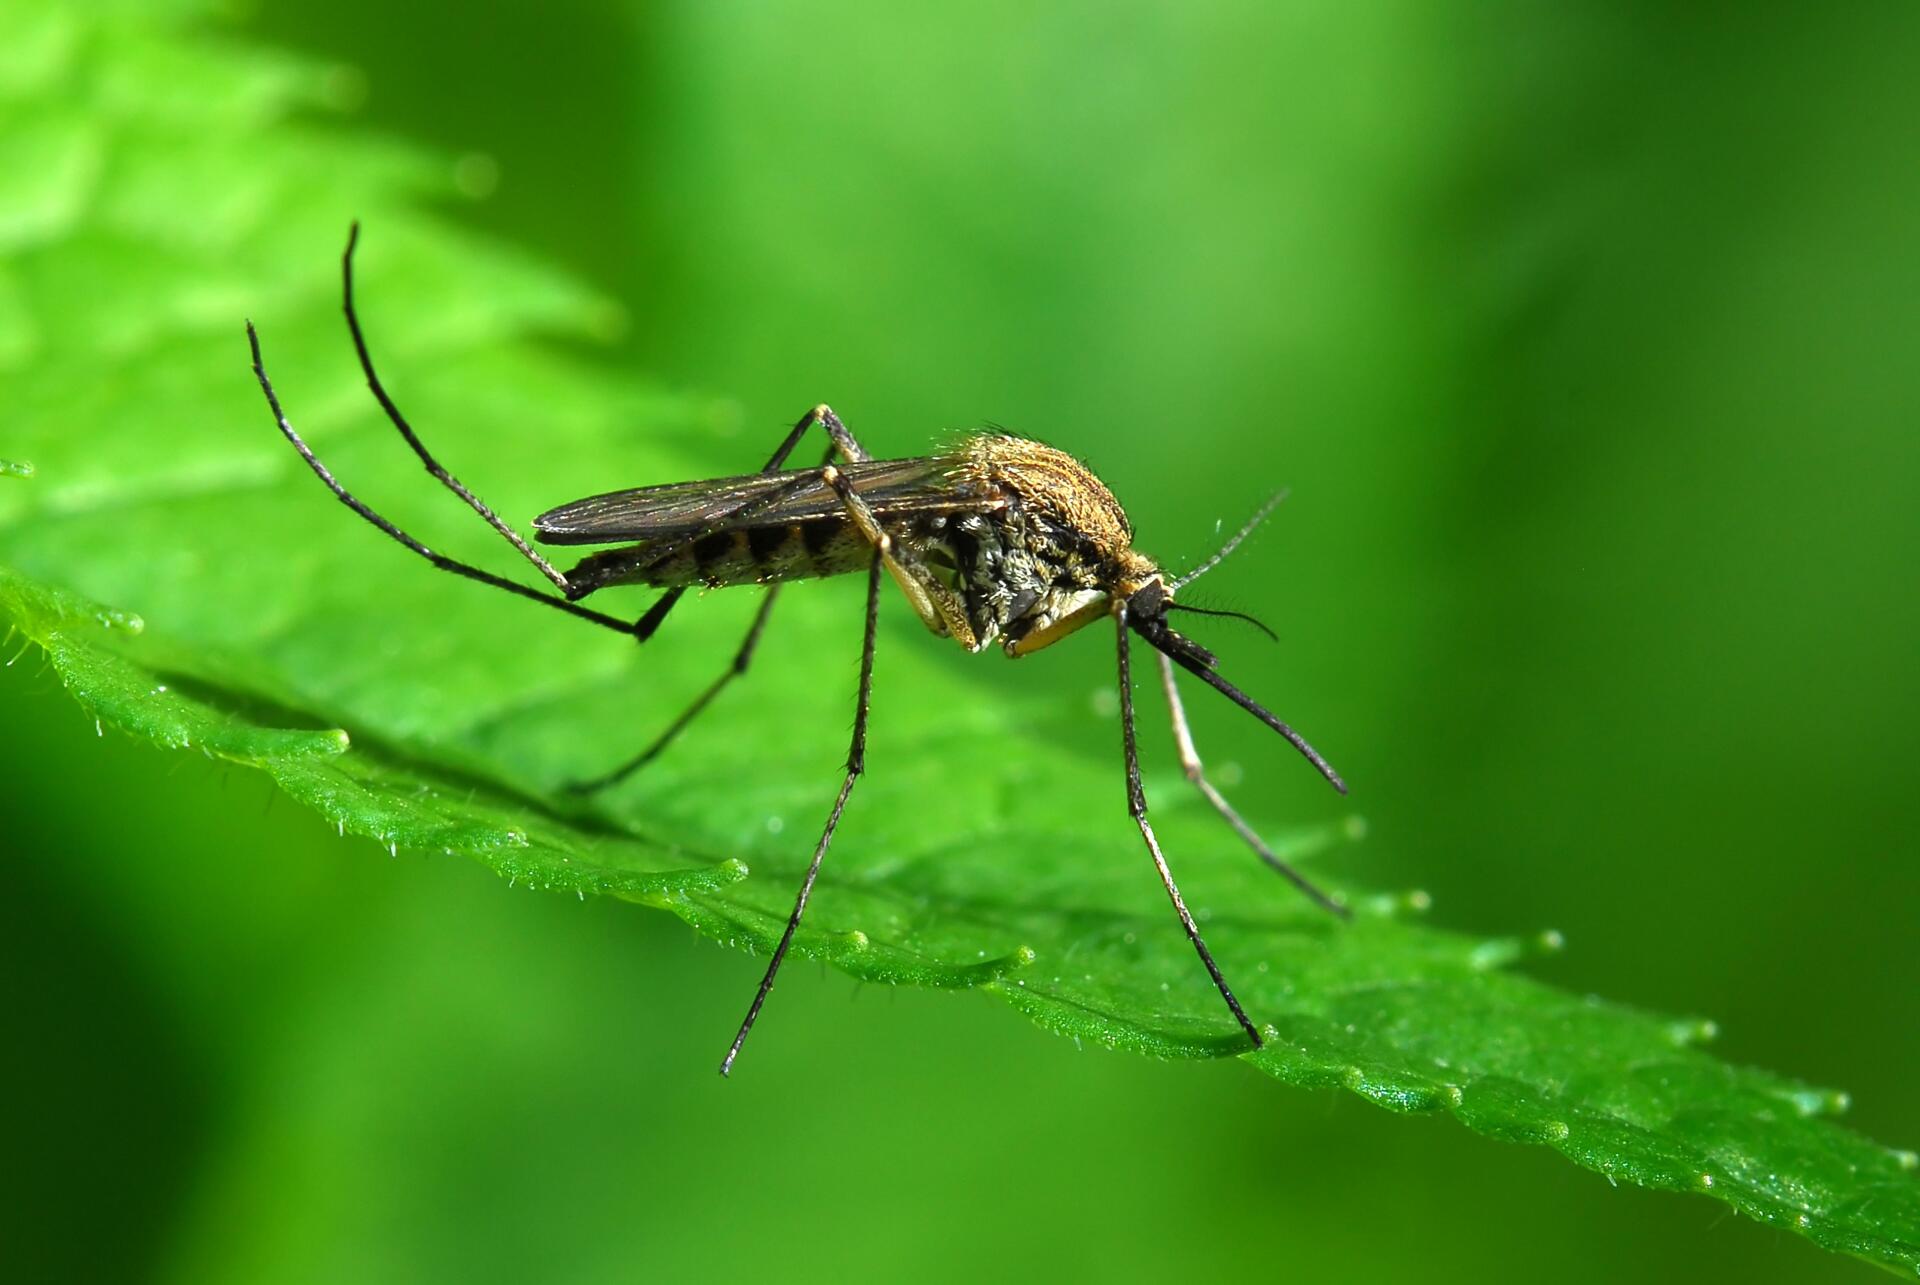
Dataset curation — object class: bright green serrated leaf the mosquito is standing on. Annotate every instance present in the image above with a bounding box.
[0,2,1920,1270]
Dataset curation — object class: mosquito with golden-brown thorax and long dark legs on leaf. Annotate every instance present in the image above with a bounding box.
[246,223,1348,1076]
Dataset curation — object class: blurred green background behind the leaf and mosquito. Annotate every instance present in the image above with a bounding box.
[0,0,1920,1281]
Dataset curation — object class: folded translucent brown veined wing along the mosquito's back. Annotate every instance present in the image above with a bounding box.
[534,455,981,544]
